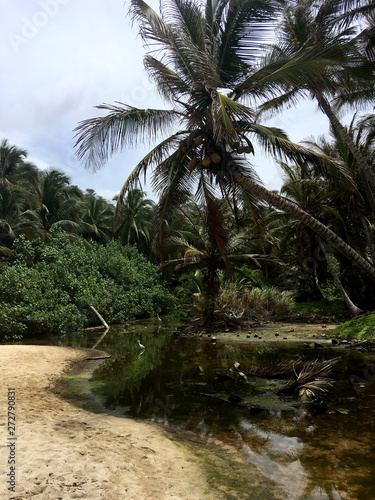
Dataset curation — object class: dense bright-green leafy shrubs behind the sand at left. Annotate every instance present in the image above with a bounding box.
[0,232,175,337]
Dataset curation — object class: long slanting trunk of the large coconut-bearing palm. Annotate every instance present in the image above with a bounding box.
[233,173,375,281]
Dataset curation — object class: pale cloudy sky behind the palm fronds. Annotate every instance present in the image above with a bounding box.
[0,0,327,200]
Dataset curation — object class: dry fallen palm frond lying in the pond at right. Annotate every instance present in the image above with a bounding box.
[278,357,341,396]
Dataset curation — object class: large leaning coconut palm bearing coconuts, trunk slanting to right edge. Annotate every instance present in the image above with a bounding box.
[76,0,375,280]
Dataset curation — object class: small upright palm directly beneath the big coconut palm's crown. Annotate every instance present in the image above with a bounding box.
[163,199,272,323]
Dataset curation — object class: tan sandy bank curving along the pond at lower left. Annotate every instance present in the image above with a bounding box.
[0,345,214,500]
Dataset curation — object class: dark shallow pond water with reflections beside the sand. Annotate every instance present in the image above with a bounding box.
[53,321,375,500]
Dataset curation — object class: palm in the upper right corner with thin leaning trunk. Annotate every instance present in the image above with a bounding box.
[258,0,375,214]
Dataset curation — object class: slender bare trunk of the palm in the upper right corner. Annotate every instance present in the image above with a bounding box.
[314,92,375,215]
